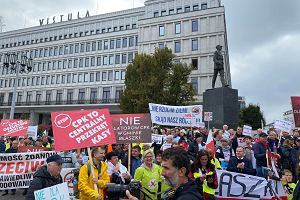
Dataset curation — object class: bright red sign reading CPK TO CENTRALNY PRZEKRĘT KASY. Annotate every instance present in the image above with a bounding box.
[51,109,116,151]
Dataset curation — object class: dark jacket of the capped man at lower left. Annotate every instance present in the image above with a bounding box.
[25,166,63,200]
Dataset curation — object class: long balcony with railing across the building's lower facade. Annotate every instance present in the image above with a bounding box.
[0,99,120,106]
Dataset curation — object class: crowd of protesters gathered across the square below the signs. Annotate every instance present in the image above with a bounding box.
[0,125,300,200]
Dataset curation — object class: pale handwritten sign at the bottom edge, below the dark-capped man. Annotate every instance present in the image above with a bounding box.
[34,182,70,200]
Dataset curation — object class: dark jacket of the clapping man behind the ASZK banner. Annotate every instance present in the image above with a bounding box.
[227,157,255,175]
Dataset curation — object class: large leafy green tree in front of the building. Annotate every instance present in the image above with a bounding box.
[120,48,195,113]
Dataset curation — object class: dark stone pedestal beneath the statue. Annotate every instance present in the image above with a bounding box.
[203,87,239,129]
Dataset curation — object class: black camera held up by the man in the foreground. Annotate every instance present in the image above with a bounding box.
[106,180,142,200]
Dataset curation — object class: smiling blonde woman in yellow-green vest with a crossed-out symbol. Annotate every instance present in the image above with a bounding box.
[134,149,162,200]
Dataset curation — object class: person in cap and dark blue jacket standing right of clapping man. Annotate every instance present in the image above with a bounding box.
[253,132,268,178]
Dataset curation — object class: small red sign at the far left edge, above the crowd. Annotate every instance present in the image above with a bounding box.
[0,119,30,137]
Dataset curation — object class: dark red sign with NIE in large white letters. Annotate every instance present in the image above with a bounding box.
[111,114,152,144]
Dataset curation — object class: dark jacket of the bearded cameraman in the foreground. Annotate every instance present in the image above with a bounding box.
[167,180,203,200]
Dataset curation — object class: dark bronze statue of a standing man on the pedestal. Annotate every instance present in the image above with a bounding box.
[212,45,227,88]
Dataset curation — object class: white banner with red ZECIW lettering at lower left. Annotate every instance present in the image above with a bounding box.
[0,151,56,190]
